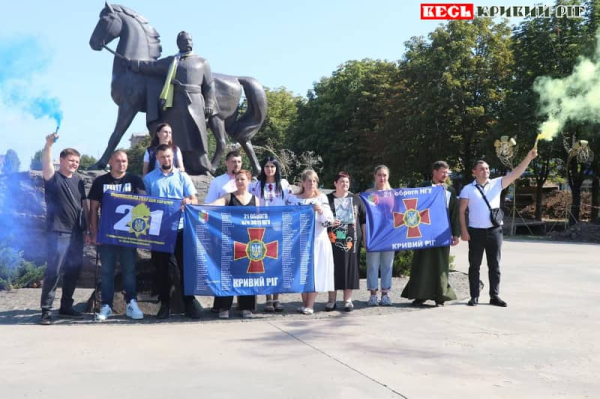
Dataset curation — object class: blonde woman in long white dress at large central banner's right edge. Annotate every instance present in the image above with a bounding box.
[288,170,334,315]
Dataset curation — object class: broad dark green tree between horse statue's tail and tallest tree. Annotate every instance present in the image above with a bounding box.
[288,59,398,190]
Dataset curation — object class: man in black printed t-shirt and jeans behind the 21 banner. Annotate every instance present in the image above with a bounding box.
[89,150,146,321]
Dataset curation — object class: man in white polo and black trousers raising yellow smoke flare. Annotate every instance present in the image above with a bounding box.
[459,148,537,307]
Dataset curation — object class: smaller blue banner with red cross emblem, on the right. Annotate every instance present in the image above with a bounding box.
[360,186,452,252]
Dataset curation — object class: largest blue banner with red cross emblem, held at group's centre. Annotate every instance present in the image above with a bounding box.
[183,205,315,296]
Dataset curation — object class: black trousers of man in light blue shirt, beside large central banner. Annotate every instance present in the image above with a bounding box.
[152,230,194,303]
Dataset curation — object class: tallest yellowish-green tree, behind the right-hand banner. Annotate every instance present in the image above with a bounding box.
[395,18,512,177]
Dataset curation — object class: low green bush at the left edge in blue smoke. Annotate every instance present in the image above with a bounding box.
[0,243,46,290]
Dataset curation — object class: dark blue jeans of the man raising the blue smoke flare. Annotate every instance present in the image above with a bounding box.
[40,231,83,310]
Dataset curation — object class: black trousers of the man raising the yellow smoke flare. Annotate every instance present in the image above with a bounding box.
[469,226,502,298]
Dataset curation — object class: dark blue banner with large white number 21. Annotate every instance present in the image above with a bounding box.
[97,191,181,253]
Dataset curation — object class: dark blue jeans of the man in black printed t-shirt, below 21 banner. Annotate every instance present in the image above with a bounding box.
[97,244,137,308]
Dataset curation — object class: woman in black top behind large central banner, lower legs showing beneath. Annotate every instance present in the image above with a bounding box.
[207,169,259,319]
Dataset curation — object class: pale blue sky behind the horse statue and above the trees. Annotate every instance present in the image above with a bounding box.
[0,0,553,170]
